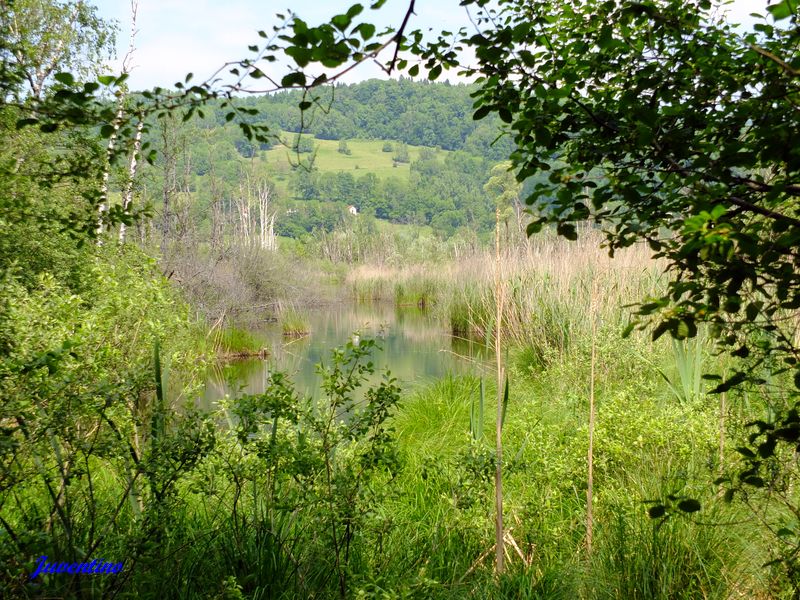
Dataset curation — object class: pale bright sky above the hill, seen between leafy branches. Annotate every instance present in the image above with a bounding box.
[93,0,766,89]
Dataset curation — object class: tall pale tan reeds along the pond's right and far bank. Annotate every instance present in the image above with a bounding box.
[348,230,660,363]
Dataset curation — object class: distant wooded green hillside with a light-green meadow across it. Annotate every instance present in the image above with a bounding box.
[130,79,510,243]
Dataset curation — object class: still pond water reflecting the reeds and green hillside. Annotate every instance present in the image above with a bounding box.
[202,304,487,408]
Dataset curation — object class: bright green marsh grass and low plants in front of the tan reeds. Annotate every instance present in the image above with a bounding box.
[383,342,769,600]
